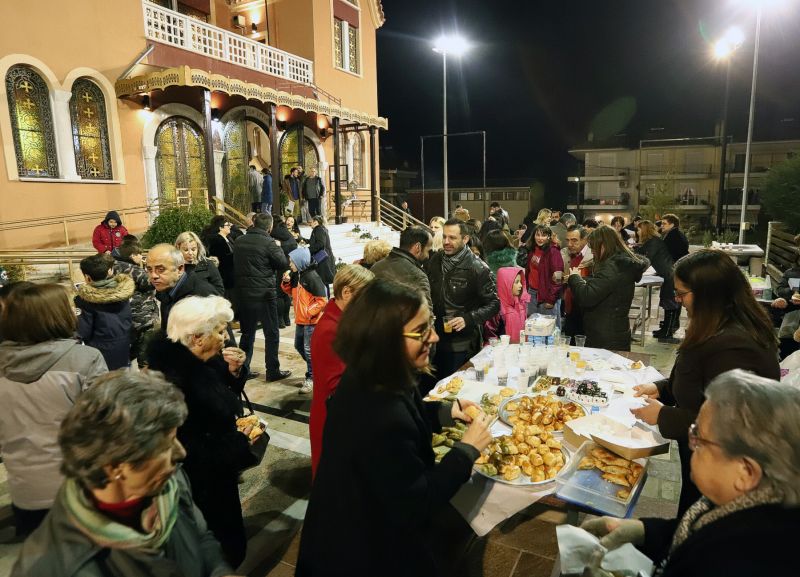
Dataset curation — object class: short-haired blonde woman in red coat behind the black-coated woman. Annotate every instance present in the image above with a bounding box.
[308,264,375,475]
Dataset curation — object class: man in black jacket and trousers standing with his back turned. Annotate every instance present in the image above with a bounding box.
[233,214,292,381]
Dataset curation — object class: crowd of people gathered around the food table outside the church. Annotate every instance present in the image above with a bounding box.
[0,199,800,576]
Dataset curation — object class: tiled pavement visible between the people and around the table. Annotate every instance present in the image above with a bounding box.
[0,299,685,577]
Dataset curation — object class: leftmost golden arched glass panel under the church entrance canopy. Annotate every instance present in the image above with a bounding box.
[155,116,208,202]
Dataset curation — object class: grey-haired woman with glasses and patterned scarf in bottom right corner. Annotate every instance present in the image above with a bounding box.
[583,369,800,577]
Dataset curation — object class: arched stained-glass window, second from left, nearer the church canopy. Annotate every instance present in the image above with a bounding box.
[69,78,112,180]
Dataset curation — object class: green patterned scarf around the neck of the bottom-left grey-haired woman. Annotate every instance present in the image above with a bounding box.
[62,476,178,551]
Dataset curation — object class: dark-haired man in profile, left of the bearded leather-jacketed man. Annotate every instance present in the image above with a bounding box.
[371,226,433,303]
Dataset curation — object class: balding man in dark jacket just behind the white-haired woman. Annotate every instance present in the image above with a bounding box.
[146,244,217,331]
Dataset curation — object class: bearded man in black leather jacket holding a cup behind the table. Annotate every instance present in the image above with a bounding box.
[427,219,500,379]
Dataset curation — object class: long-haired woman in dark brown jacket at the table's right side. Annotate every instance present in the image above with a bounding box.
[633,249,780,514]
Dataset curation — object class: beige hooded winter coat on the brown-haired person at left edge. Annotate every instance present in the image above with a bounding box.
[0,339,108,510]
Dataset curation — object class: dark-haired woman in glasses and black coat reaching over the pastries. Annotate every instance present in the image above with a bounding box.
[295,279,491,577]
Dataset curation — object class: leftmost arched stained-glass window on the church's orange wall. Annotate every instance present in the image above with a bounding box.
[6,65,58,178]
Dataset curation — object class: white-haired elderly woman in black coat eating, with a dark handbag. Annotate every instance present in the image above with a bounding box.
[148,296,256,567]
